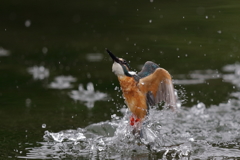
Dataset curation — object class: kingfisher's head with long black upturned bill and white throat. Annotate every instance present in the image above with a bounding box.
[106,49,133,77]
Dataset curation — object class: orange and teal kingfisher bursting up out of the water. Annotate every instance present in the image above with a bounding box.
[106,49,176,130]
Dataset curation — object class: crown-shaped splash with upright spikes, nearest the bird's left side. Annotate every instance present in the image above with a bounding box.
[69,82,108,108]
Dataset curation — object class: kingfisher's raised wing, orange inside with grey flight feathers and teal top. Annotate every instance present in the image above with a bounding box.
[138,61,176,108]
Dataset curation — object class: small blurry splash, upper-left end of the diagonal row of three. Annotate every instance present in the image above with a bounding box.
[27,66,49,80]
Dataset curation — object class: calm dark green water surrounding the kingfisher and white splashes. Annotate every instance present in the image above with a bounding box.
[0,0,240,159]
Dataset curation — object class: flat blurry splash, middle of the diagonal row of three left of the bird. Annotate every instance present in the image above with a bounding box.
[48,76,77,89]
